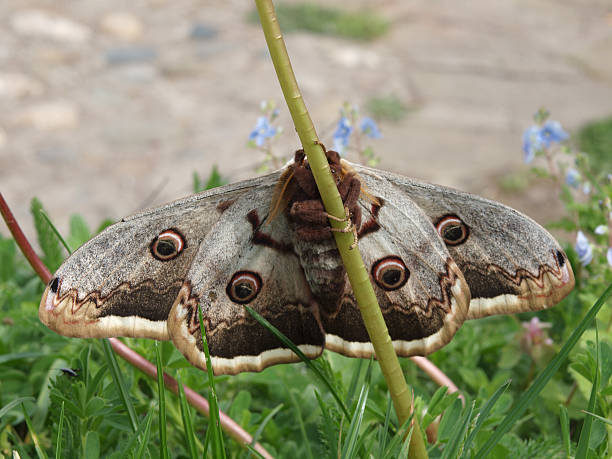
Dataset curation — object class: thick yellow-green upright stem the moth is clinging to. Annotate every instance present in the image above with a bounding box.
[255,0,427,458]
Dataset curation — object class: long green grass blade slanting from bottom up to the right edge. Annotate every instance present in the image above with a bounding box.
[475,284,612,459]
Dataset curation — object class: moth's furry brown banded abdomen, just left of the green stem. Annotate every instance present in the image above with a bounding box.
[294,238,346,311]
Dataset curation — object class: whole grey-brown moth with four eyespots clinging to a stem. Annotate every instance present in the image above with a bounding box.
[39,151,574,374]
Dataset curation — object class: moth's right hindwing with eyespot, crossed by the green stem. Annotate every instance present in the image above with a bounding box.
[321,169,470,357]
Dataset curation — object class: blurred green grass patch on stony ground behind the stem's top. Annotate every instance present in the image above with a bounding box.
[248,2,389,41]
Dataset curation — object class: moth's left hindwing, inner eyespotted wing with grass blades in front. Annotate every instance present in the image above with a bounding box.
[168,189,324,374]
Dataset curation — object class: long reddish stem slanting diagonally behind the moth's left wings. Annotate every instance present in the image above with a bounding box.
[0,193,272,459]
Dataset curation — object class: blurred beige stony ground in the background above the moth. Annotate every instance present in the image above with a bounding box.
[0,0,612,241]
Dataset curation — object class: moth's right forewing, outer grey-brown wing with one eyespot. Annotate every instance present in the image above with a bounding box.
[355,166,574,319]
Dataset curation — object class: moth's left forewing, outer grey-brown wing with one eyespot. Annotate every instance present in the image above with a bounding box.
[39,173,279,340]
